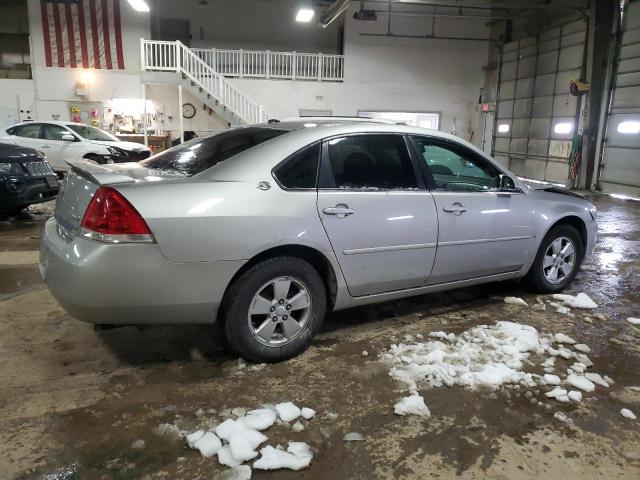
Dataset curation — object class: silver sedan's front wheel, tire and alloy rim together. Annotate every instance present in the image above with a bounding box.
[526,225,584,293]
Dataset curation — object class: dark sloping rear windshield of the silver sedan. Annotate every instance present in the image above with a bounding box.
[140,127,288,176]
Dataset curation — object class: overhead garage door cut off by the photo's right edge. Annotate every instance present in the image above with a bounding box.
[600,1,640,197]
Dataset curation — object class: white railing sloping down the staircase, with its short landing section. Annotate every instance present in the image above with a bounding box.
[140,39,272,123]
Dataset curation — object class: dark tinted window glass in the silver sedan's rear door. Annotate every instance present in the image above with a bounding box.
[321,134,418,190]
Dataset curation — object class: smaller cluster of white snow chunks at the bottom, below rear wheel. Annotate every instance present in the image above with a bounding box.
[179,402,316,472]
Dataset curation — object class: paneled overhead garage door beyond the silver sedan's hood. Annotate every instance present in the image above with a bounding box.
[493,21,586,183]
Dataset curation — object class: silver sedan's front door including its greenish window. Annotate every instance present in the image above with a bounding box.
[412,136,533,284]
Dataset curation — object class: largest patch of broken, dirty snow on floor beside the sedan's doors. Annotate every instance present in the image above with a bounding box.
[380,321,613,417]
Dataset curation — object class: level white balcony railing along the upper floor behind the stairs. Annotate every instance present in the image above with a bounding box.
[191,48,344,82]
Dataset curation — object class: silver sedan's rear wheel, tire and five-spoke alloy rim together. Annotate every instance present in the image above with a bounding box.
[223,257,326,362]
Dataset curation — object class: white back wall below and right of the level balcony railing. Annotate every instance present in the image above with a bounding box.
[233,4,489,142]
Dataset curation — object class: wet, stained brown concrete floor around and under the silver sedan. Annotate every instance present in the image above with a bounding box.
[0,196,640,479]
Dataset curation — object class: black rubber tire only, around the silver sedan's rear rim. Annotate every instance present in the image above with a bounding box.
[222,257,327,363]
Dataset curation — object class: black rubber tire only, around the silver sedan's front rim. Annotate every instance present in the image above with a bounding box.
[525,224,584,293]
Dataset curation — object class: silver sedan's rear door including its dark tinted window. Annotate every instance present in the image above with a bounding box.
[318,133,437,296]
